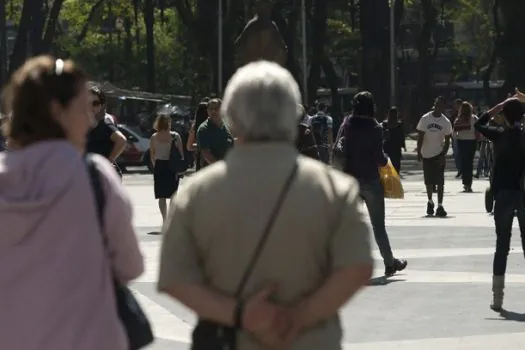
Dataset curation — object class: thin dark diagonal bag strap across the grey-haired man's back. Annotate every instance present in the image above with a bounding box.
[235,161,298,298]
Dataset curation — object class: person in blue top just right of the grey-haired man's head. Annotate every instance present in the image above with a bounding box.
[308,102,334,164]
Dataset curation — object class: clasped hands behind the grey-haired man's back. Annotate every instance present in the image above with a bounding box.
[242,285,304,349]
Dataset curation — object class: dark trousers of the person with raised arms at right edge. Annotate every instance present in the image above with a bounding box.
[493,190,525,276]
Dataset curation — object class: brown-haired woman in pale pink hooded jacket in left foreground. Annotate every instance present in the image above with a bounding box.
[0,56,143,350]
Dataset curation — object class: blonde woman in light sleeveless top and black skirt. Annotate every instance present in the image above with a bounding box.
[150,115,184,222]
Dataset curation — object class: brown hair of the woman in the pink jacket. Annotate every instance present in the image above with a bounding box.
[2,56,87,147]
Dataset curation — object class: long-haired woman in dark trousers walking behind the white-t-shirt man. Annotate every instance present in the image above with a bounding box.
[453,102,478,193]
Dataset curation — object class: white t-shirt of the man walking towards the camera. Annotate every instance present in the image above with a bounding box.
[417,112,452,158]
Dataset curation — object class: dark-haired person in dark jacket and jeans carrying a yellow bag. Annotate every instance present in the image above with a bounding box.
[342,91,407,276]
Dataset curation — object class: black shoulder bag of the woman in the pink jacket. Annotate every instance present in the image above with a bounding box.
[85,154,155,350]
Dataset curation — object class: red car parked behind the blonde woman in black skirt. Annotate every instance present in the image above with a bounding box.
[117,124,152,171]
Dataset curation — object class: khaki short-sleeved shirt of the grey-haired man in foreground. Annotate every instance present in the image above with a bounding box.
[158,144,373,350]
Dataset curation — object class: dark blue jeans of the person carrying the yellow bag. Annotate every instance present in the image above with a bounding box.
[359,179,394,266]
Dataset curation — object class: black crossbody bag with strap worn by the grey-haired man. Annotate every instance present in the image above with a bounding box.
[191,163,298,350]
